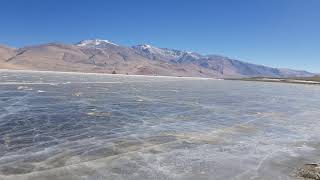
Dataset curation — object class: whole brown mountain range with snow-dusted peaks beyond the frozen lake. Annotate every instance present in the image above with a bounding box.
[0,39,314,77]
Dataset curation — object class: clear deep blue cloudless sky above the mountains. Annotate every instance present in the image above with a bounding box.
[0,0,320,72]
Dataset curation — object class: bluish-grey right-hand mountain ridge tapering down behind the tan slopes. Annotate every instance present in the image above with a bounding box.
[133,45,312,77]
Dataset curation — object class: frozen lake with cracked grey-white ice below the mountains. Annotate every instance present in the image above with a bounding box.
[0,70,320,180]
